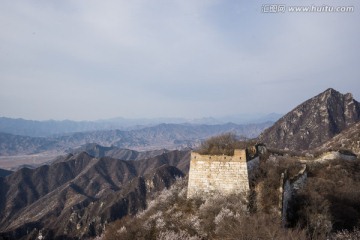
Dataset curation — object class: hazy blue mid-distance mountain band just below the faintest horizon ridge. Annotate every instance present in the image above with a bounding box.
[0,122,272,156]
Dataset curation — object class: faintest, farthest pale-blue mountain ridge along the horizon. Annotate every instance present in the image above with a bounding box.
[0,113,281,137]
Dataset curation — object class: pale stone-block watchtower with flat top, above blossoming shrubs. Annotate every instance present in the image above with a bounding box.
[187,149,259,198]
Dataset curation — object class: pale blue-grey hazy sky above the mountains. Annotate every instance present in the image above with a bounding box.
[0,0,360,120]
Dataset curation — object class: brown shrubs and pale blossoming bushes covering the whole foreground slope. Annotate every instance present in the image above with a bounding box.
[104,156,360,240]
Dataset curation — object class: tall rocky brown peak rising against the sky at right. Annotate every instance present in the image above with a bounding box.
[259,88,360,151]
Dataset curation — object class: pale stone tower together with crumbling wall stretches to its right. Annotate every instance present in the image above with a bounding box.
[187,144,356,227]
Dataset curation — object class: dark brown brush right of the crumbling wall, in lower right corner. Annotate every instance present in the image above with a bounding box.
[292,160,360,239]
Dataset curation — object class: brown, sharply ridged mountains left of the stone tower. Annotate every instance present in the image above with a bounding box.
[0,151,190,239]
